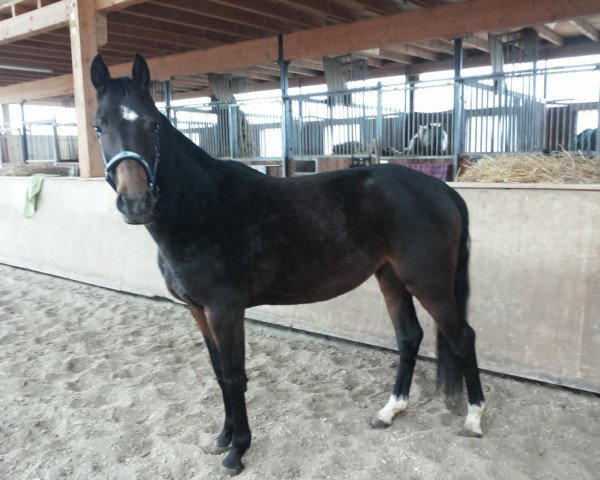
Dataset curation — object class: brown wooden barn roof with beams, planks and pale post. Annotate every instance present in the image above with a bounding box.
[0,0,600,176]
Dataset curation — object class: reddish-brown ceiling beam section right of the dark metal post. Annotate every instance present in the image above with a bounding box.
[284,0,600,60]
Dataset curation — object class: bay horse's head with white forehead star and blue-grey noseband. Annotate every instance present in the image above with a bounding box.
[91,54,163,224]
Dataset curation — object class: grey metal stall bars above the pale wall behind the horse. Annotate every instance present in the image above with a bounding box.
[0,65,600,174]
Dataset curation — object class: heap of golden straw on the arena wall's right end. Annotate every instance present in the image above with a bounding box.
[458,151,600,183]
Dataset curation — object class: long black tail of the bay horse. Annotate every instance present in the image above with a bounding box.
[437,189,470,398]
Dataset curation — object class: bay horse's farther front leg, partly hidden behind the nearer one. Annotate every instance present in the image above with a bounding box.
[190,306,233,455]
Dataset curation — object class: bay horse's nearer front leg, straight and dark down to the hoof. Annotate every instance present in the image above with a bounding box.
[205,307,251,475]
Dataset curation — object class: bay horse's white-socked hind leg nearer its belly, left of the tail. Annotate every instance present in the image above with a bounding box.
[371,264,423,428]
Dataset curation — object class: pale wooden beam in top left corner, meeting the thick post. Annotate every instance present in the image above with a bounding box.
[0,0,68,45]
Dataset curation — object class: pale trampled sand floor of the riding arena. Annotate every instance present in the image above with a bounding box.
[0,265,600,480]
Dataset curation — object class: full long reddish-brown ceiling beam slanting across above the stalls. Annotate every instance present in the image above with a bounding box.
[0,0,600,103]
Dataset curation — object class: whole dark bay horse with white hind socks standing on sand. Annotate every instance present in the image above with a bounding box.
[91,55,485,475]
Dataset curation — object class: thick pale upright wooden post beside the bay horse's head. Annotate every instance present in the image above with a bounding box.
[68,0,104,177]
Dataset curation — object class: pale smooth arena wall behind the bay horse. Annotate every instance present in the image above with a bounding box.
[0,177,600,392]
